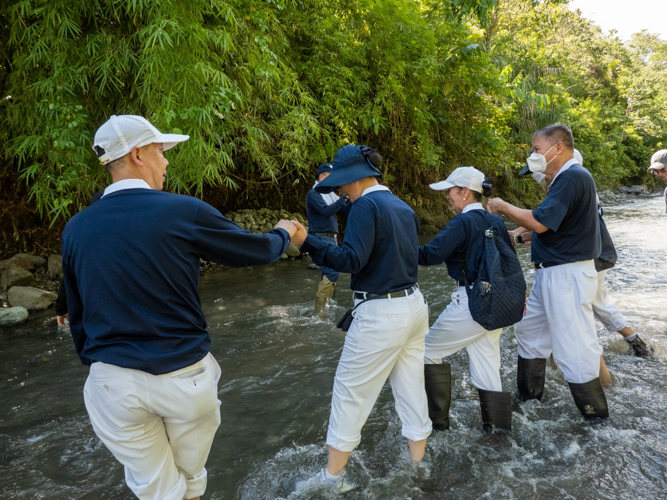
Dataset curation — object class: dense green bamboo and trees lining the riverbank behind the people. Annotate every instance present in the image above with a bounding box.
[0,0,667,255]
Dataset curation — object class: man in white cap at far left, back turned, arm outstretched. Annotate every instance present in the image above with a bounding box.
[63,116,305,500]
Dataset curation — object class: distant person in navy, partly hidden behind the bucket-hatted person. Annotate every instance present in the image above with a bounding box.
[306,163,352,314]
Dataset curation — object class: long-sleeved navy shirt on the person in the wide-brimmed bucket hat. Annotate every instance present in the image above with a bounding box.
[302,188,419,295]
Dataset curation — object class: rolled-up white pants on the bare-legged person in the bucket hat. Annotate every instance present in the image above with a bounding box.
[327,290,432,452]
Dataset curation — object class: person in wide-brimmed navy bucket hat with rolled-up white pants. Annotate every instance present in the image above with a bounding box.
[300,145,432,492]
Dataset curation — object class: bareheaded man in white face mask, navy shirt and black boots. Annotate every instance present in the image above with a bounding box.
[487,123,609,419]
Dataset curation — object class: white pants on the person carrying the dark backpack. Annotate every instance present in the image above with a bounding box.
[424,286,503,392]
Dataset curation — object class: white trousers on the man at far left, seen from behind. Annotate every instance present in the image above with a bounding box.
[83,353,220,500]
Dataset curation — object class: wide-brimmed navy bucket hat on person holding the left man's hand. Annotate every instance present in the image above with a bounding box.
[315,144,382,194]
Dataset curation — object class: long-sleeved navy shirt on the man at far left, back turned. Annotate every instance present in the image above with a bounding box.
[63,189,290,375]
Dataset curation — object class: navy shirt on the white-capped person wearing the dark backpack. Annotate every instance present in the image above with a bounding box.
[419,203,514,284]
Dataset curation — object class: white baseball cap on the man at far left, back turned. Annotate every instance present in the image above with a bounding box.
[93,115,190,165]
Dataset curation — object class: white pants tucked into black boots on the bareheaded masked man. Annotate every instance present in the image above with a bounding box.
[514,260,602,384]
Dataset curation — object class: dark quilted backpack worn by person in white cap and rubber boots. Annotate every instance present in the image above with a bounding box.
[461,210,526,331]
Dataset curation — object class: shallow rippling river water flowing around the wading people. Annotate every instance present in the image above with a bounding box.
[0,194,667,500]
